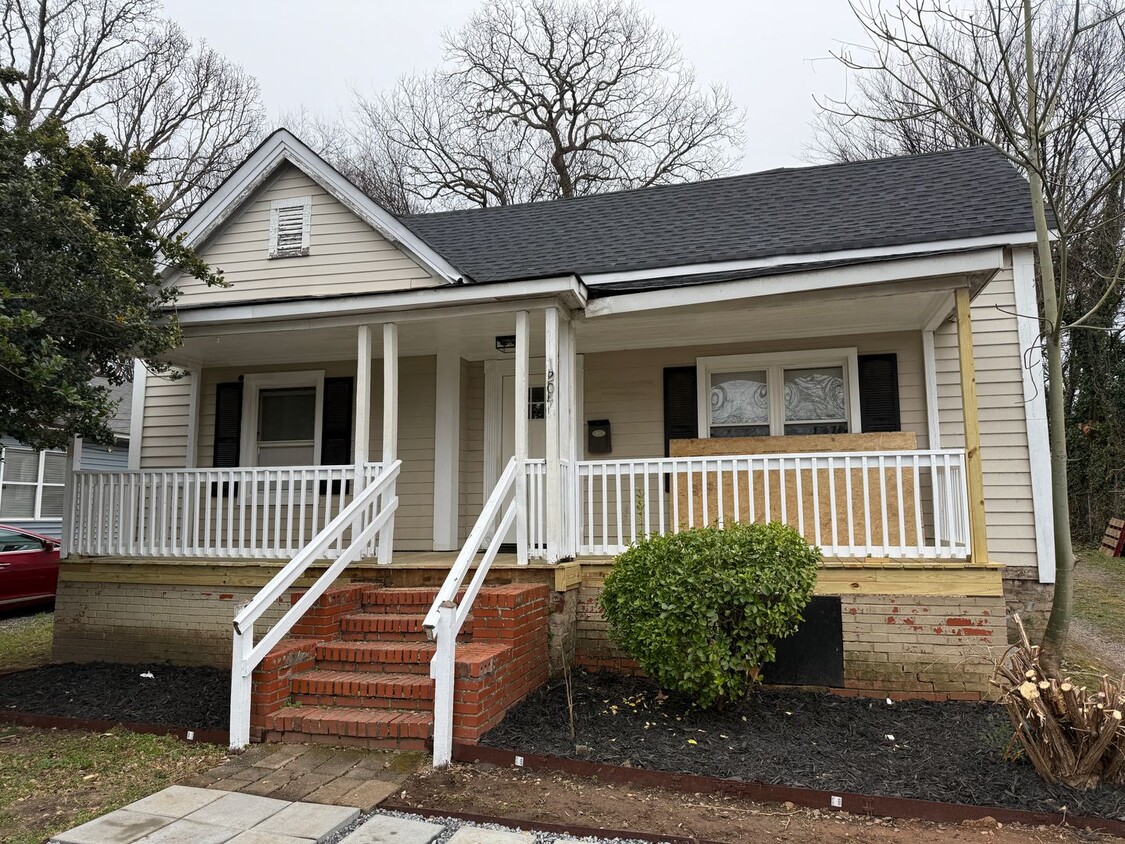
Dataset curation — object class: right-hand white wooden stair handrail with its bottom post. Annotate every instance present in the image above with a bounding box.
[422,457,528,767]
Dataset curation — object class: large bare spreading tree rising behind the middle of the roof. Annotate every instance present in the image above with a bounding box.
[351,0,743,207]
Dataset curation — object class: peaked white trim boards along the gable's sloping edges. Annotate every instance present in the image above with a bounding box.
[164,129,464,284]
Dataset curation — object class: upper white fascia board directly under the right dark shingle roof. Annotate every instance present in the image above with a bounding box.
[582,232,1035,287]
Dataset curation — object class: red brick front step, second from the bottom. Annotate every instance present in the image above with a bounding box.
[291,670,433,711]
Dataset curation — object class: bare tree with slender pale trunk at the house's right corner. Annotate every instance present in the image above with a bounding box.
[820,0,1125,671]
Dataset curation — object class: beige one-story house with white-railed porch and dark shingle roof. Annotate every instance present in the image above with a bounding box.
[55,125,1054,747]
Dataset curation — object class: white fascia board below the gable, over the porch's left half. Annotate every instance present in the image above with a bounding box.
[177,276,586,326]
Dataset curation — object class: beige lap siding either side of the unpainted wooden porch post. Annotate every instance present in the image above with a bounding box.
[934,269,1037,566]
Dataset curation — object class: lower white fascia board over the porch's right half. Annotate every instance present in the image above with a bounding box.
[583,246,1005,317]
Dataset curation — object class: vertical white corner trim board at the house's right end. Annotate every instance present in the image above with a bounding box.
[1011,248,1055,583]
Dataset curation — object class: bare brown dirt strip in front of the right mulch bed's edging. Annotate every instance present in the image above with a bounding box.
[383,765,1119,844]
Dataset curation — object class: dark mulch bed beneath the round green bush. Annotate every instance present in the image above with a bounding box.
[482,672,1125,820]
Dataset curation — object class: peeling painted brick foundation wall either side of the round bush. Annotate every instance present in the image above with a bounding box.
[575,577,1007,700]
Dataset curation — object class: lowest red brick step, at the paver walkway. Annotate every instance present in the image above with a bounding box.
[268,707,433,748]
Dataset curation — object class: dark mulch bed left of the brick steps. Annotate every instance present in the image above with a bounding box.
[0,663,231,729]
